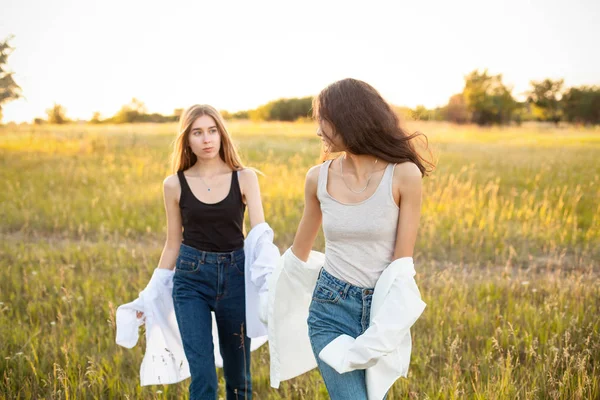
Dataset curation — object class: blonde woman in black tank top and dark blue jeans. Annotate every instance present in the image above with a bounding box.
[159,105,264,400]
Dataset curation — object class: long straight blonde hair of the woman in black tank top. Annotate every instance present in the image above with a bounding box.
[171,104,244,172]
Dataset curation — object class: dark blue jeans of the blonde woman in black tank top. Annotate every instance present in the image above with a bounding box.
[173,244,252,400]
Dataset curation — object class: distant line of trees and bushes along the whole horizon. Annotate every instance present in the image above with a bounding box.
[0,37,600,125]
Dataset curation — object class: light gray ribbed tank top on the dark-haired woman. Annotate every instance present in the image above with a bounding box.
[317,160,400,288]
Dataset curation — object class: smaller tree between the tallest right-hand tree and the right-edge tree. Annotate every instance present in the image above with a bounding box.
[527,79,565,125]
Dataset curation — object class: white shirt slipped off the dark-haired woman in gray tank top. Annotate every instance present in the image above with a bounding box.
[268,249,425,400]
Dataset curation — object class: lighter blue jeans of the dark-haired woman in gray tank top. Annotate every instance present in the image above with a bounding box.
[308,269,373,400]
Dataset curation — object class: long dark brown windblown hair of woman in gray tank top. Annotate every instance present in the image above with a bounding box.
[313,78,434,176]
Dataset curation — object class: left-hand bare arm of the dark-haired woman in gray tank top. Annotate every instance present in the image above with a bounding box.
[292,165,323,261]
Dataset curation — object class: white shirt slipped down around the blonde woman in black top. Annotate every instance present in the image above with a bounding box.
[116,223,280,386]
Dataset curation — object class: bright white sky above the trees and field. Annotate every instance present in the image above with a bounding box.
[0,0,600,122]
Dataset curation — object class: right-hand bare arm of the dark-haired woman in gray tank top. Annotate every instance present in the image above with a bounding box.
[394,162,423,260]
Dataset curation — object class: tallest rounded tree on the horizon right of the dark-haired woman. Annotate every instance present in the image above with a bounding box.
[462,70,517,125]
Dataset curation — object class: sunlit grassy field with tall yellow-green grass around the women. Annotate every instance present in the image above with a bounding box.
[0,122,600,400]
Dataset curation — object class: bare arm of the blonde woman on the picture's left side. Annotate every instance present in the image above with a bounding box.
[158,175,183,269]
